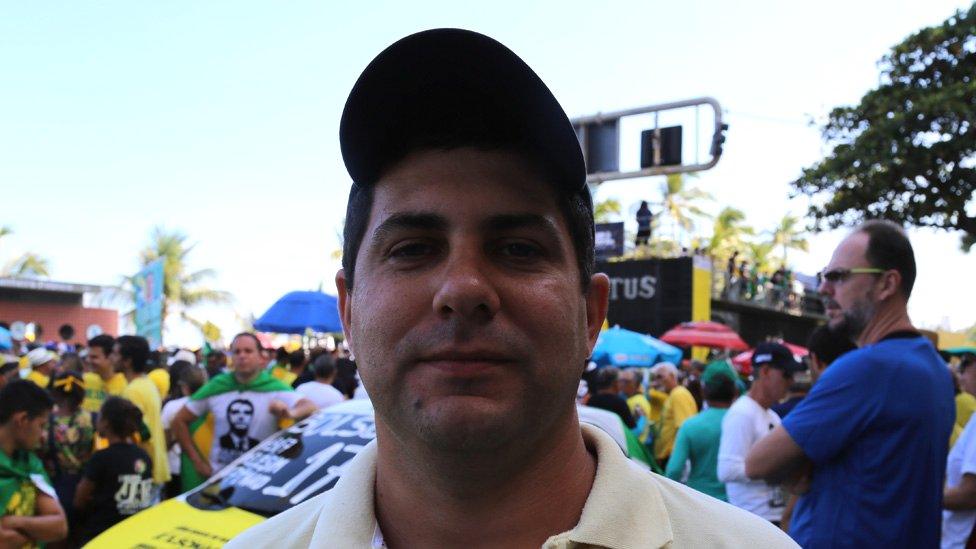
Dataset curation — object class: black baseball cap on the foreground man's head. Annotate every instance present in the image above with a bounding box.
[339,29,589,197]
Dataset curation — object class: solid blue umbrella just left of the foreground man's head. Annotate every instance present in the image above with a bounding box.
[254,292,342,334]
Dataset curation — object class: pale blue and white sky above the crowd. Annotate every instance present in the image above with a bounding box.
[0,0,976,343]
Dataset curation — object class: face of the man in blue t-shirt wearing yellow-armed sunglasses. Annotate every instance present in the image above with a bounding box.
[820,233,877,340]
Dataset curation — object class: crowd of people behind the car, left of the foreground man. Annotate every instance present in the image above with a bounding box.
[0,333,363,547]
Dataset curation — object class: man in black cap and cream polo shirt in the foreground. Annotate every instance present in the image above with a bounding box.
[230,29,792,547]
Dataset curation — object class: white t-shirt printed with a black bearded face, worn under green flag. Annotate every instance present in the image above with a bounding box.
[186,391,302,472]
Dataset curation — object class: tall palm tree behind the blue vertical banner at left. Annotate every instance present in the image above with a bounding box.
[127,227,232,327]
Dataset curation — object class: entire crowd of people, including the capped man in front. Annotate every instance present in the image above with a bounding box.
[0,29,976,549]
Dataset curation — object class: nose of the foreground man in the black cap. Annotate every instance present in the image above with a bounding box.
[433,250,500,320]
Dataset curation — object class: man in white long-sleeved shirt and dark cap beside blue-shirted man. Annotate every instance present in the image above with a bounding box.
[718,342,803,524]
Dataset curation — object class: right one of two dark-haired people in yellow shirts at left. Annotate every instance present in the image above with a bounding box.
[110,335,170,489]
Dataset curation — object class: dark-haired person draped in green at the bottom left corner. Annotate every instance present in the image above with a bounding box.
[0,381,68,547]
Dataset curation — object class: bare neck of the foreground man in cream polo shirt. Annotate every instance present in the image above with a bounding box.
[375,411,596,547]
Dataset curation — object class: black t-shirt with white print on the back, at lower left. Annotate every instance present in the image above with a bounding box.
[82,443,153,540]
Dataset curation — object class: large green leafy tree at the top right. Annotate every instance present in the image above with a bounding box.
[792,4,976,251]
